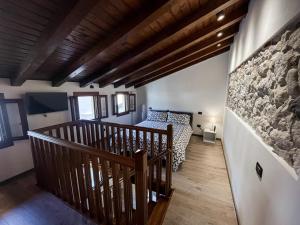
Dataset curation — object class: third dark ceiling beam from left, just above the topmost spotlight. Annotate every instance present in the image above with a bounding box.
[80,0,244,87]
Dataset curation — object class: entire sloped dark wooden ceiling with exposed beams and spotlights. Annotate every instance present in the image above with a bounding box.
[0,0,249,87]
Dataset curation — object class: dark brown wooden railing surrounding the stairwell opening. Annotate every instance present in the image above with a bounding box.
[28,120,172,225]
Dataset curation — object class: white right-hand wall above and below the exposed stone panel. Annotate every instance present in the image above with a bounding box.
[223,0,300,225]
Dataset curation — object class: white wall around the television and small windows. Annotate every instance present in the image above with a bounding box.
[0,79,138,182]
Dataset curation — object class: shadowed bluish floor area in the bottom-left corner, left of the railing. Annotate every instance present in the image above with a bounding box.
[0,173,95,225]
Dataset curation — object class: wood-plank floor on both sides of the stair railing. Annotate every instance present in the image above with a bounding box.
[0,136,237,225]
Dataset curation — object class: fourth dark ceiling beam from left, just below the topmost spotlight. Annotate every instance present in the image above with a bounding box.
[99,2,247,87]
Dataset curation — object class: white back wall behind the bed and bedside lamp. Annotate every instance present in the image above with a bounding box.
[137,52,228,137]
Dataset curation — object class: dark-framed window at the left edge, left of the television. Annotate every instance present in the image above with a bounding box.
[0,94,28,148]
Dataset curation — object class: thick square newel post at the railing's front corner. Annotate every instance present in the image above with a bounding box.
[134,150,148,225]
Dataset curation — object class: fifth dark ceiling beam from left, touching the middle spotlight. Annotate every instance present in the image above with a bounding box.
[114,24,239,88]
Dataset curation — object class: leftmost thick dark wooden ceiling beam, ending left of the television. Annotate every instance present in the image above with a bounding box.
[11,0,99,86]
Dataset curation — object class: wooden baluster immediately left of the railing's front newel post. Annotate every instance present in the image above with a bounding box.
[123,167,133,225]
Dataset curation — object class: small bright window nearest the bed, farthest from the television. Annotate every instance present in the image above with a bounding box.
[112,92,129,116]
